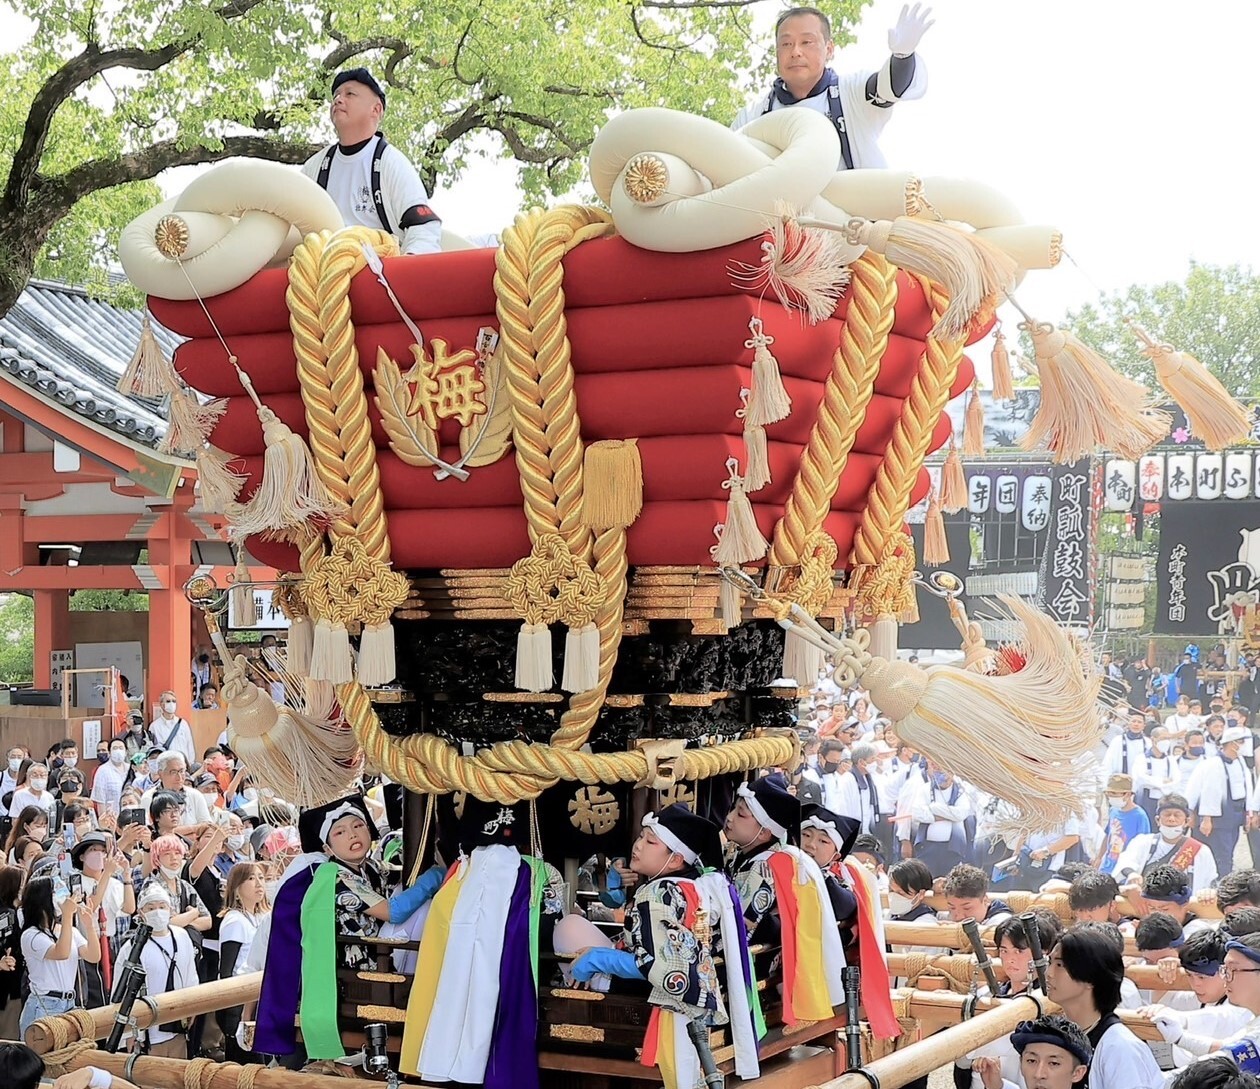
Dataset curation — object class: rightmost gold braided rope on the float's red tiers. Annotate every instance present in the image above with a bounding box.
[849,280,964,579]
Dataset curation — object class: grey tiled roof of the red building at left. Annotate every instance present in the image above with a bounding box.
[0,280,183,446]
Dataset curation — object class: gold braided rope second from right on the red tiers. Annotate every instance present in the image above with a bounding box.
[770,250,897,567]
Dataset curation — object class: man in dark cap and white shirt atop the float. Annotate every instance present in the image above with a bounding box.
[302,68,442,253]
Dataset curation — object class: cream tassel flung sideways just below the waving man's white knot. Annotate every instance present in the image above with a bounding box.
[845,216,1019,340]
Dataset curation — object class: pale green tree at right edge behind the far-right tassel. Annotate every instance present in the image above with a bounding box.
[1067,263,1260,398]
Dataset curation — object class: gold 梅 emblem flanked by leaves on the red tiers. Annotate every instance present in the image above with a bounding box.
[373,330,512,478]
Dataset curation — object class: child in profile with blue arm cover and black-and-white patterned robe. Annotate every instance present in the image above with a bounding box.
[571,804,760,1089]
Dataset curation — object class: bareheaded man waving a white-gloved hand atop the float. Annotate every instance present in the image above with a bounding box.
[731,4,932,170]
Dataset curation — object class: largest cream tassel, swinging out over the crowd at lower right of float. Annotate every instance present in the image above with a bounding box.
[861,596,1100,831]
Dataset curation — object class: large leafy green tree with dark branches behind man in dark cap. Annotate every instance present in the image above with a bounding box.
[0,0,869,314]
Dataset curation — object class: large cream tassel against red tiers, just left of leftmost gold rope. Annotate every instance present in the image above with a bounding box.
[229,406,349,541]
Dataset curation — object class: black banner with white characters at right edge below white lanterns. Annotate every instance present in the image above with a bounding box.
[1155,499,1260,635]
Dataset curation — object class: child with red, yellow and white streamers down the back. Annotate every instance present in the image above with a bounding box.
[725,775,844,1026]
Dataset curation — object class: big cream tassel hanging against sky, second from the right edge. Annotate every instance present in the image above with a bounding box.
[1019,319,1171,464]
